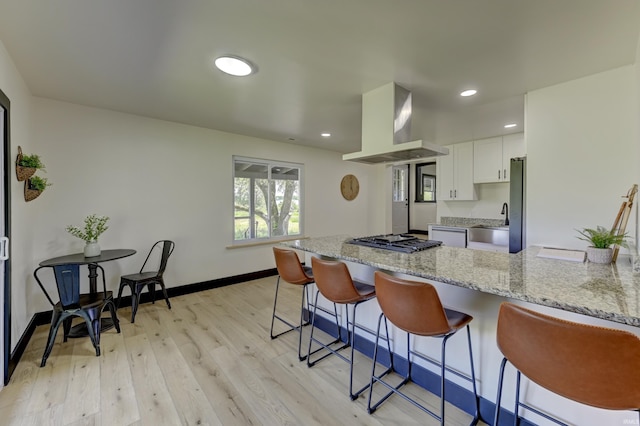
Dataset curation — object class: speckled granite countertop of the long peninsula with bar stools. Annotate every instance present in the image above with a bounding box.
[283,235,640,327]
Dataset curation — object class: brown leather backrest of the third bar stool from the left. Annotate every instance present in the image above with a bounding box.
[374,271,451,336]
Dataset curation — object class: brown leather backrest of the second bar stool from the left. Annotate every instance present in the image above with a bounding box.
[311,257,361,303]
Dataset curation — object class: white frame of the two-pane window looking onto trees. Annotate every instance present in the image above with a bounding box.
[231,155,305,246]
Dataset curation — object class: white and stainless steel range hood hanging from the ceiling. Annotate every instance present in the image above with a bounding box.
[342,83,449,164]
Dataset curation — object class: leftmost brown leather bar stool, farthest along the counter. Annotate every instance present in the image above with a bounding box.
[270,247,314,361]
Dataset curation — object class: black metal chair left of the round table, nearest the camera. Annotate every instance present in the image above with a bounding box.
[33,264,120,367]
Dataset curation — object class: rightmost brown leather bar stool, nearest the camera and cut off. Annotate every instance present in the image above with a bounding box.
[493,302,640,425]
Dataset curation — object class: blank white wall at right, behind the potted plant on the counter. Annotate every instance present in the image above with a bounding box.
[526,66,640,248]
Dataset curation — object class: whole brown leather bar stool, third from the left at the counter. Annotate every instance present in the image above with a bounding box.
[367,271,480,425]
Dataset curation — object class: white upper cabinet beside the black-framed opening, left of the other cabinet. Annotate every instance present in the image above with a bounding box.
[437,142,477,201]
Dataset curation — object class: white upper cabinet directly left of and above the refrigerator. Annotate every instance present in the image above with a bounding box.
[473,133,526,183]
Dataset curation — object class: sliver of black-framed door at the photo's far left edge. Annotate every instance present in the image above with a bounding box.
[0,90,9,385]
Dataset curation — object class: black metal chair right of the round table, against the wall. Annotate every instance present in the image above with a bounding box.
[118,240,175,323]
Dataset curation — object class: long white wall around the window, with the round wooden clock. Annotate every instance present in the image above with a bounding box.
[23,98,384,314]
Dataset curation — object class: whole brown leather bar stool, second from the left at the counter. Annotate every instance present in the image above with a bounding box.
[307,257,376,400]
